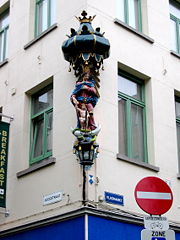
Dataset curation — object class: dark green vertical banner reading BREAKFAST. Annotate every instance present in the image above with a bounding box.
[0,122,9,208]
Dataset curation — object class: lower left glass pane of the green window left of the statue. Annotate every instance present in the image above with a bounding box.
[33,118,44,158]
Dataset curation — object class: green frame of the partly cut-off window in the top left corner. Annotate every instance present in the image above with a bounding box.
[0,8,9,63]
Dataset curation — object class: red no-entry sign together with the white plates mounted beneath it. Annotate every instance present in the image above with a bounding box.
[134,177,175,240]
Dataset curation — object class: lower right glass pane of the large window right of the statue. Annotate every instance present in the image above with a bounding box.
[131,104,144,161]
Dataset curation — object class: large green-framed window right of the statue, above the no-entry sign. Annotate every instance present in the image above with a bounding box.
[118,72,147,162]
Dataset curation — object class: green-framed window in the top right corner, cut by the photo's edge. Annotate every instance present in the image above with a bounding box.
[170,1,180,54]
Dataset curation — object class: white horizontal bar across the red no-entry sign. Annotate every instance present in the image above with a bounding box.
[137,191,172,200]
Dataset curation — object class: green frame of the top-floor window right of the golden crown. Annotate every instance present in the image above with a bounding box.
[117,0,142,32]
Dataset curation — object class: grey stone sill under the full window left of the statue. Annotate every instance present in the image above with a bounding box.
[16,157,56,178]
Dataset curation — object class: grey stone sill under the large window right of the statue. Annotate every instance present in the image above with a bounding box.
[117,153,159,172]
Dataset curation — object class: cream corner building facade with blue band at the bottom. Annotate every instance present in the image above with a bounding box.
[0,0,180,240]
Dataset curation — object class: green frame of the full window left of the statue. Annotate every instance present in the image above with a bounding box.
[29,84,53,165]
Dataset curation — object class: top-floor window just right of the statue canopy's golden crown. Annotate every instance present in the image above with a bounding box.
[117,0,142,32]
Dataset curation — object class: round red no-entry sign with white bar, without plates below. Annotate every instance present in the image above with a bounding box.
[134,177,173,215]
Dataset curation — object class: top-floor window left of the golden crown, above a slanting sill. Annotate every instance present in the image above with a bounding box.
[35,0,55,36]
